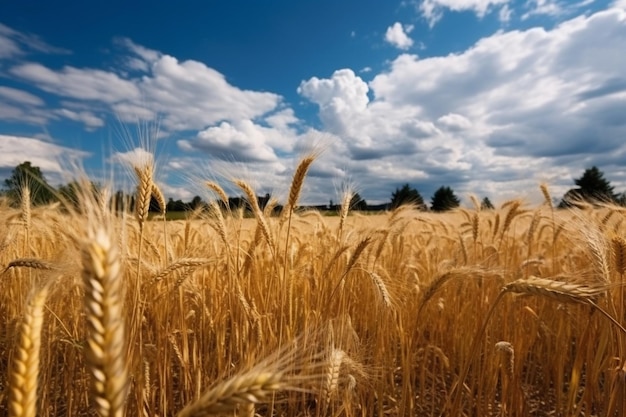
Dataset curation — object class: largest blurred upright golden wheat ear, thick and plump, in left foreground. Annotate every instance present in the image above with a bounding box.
[82,228,127,417]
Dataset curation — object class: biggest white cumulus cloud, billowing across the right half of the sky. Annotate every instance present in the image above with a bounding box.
[299,9,626,203]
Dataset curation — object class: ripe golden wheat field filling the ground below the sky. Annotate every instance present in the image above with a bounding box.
[0,154,626,417]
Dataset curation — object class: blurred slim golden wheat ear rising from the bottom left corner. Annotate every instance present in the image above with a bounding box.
[9,287,48,417]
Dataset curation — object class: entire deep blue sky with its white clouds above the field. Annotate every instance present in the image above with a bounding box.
[0,0,626,203]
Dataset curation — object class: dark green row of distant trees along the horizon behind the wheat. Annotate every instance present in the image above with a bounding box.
[2,161,626,212]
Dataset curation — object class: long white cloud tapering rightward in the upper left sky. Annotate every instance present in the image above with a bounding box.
[0,27,282,131]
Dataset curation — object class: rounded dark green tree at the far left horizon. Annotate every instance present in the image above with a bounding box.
[4,161,55,206]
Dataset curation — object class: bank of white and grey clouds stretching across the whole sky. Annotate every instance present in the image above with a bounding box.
[0,4,626,203]
